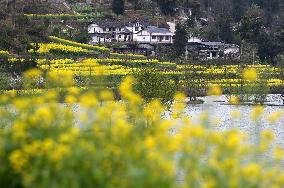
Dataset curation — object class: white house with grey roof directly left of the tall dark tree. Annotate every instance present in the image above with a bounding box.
[133,26,174,43]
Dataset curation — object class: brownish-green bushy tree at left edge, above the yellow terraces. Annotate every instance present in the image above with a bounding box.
[0,4,49,54]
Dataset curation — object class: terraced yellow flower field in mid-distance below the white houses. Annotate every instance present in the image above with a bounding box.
[2,36,284,97]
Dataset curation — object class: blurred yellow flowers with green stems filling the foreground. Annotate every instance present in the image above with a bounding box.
[0,74,284,187]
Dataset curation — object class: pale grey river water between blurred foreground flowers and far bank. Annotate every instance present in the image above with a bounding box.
[183,95,284,147]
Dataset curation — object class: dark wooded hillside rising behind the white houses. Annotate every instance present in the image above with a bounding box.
[0,0,284,65]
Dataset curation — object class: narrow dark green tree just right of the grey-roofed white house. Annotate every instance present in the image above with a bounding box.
[173,23,188,57]
